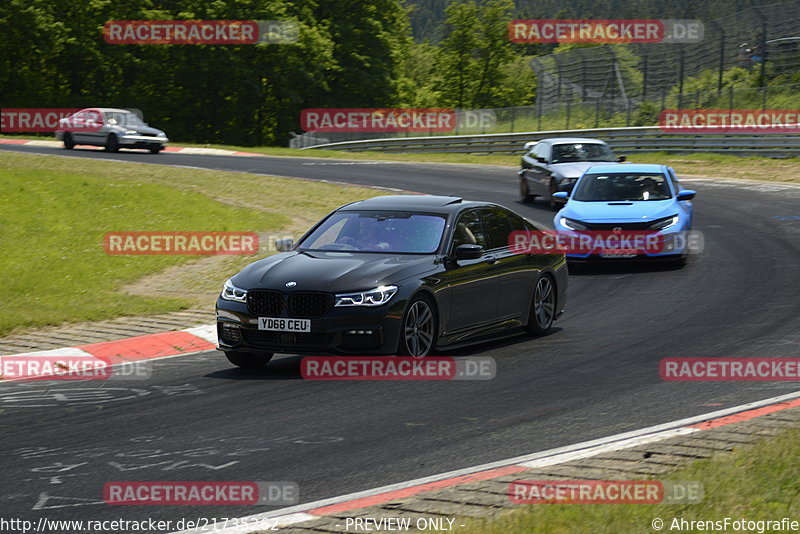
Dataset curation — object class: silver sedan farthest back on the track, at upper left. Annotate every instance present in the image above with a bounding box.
[56,108,169,154]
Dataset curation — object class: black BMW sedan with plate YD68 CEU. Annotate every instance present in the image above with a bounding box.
[217,195,567,368]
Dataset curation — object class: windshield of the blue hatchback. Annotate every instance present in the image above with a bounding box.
[572,172,672,202]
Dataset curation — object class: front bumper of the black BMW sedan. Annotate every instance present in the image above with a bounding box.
[217,298,404,355]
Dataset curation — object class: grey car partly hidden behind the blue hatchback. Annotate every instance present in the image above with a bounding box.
[518,137,625,209]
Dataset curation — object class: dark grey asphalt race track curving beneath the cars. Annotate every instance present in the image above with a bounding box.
[0,146,800,532]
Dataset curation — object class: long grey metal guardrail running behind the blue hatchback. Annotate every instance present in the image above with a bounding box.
[304,126,800,157]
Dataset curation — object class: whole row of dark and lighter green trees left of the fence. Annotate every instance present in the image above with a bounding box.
[0,0,784,146]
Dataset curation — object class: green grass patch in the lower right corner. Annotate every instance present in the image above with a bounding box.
[456,429,800,534]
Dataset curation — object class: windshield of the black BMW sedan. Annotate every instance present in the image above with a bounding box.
[299,211,445,254]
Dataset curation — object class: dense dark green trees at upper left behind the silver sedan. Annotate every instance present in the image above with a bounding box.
[0,0,410,145]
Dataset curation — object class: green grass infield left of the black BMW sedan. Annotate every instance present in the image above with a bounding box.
[0,152,379,335]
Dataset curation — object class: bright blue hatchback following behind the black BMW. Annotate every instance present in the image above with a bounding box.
[553,164,696,263]
